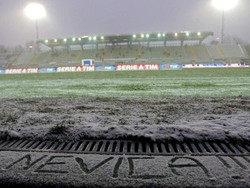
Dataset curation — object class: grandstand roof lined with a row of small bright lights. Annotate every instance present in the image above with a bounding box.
[38,31,213,47]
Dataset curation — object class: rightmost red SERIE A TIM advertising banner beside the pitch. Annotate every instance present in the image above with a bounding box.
[116,64,160,71]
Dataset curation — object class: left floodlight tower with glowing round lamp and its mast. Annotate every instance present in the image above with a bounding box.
[24,3,46,52]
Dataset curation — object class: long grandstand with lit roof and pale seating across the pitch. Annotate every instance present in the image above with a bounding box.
[0,31,250,68]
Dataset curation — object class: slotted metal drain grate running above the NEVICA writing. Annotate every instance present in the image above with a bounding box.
[0,140,250,155]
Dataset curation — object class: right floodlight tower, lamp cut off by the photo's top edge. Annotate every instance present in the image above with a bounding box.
[212,0,239,44]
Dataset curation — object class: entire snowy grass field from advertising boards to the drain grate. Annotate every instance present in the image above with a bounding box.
[0,68,250,141]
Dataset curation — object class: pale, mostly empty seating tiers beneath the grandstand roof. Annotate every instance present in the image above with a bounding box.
[0,44,249,68]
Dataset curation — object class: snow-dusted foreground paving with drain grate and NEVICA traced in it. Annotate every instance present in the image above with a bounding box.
[0,140,250,188]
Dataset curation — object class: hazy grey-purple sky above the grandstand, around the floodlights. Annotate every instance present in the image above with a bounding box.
[0,0,250,46]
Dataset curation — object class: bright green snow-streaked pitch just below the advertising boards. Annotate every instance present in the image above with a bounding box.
[0,68,250,98]
